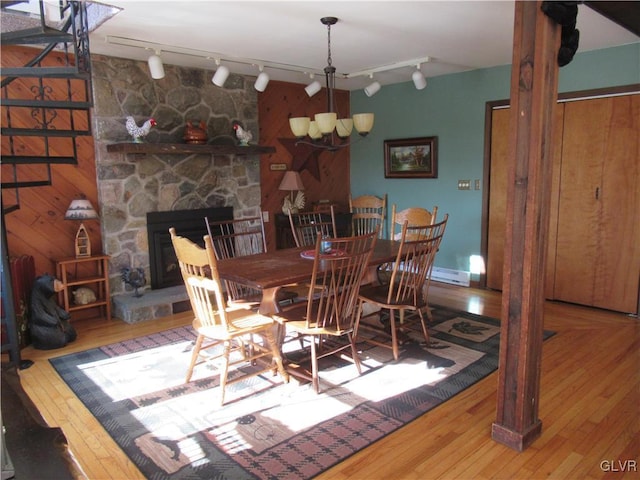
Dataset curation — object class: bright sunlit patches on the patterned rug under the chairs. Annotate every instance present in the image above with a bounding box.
[66,330,484,458]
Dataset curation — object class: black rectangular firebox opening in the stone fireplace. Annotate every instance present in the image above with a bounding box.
[147,207,233,290]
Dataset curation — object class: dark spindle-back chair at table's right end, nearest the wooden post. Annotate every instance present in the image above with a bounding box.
[354,214,449,360]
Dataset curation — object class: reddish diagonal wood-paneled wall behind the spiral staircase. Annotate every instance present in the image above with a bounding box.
[1,46,102,275]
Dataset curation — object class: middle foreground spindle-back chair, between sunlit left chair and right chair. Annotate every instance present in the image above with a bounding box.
[273,231,378,392]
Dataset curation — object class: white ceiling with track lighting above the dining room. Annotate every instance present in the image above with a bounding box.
[90,0,640,90]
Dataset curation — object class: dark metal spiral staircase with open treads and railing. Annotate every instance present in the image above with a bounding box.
[0,0,93,368]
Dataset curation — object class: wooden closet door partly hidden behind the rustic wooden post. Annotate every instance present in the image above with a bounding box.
[486,104,564,298]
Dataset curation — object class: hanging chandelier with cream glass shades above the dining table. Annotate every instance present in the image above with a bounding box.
[289,17,374,150]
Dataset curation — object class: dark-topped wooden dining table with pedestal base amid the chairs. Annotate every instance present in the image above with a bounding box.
[218,239,400,315]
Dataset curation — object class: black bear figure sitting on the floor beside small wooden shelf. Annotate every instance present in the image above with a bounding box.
[29,274,77,350]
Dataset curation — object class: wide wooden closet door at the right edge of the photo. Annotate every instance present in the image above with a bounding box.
[552,95,640,312]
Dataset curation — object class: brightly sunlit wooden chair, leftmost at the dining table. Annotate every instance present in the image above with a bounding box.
[169,227,289,405]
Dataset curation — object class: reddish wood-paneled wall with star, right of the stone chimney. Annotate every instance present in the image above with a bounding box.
[258,81,350,249]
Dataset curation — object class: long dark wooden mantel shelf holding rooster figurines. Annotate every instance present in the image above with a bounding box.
[107,143,276,155]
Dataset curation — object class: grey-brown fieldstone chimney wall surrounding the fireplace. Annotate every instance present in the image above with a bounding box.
[92,55,261,298]
